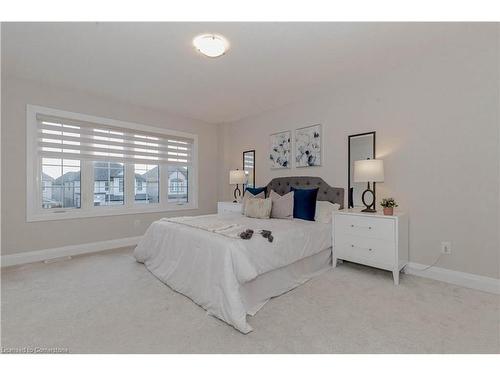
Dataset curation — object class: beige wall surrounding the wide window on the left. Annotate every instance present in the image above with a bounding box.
[1,78,218,255]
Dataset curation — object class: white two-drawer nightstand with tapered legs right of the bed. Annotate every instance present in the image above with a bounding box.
[332,209,408,285]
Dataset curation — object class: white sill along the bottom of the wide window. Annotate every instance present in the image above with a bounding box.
[26,204,198,223]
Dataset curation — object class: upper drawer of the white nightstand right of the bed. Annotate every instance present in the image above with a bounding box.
[335,215,395,242]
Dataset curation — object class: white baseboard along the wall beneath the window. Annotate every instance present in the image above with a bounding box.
[2,236,141,267]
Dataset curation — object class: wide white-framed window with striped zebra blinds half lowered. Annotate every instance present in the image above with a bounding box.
[27,105,197,221]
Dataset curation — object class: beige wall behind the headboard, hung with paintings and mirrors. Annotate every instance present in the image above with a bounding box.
[220,25,499,277]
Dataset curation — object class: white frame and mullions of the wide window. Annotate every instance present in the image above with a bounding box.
[26,104,199,222]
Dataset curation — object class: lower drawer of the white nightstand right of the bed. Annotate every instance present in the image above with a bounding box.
[335,233,396,267]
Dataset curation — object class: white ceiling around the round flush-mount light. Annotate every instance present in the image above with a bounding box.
[2,23,467,123]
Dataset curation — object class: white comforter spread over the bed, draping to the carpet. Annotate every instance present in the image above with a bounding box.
[134,213,332,333]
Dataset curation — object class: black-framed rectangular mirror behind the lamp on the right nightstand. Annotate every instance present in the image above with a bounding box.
[347,132,375,208]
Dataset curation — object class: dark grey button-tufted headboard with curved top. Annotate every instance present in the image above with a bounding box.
[266,176,344,208]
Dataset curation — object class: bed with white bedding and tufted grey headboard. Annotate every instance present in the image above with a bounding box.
[134,177,344,333]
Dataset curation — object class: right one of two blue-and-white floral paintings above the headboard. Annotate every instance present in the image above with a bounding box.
[295,124,321,167]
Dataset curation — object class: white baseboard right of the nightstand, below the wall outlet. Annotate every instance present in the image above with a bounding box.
[406,262,500,294]
